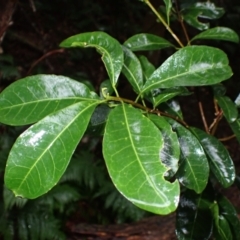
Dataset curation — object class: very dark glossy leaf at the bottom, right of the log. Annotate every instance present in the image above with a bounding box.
[176,190,213,240]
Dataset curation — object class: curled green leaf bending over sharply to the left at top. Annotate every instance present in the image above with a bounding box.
[60,32,123,87]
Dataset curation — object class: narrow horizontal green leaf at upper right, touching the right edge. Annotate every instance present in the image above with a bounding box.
[191,27,239,43]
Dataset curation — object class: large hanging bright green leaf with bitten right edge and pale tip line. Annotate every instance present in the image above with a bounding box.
[103,104,179,214]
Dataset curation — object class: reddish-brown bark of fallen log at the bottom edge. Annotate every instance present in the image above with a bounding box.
[68,214,177,240]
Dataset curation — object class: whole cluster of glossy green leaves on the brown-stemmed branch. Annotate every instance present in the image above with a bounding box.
[0,0,240,239]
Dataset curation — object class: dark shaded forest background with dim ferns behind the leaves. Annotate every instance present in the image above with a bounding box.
[0,0,240,239]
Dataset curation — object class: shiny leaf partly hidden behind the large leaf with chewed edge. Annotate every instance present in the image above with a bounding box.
[148,114,180,178]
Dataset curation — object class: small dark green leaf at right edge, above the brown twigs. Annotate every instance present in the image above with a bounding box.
[215,96,238,123]
